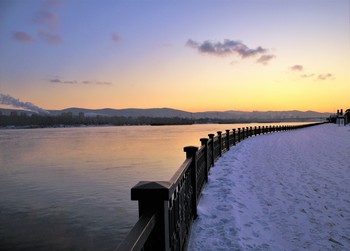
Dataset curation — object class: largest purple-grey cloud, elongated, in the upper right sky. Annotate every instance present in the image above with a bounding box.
[186,39,267,58]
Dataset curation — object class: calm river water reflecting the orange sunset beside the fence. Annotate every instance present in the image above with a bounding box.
[0,123,312,250]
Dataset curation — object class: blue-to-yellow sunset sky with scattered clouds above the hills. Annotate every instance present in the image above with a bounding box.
[0,0,350,112]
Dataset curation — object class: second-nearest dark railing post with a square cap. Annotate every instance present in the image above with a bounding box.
[184,146,198,219]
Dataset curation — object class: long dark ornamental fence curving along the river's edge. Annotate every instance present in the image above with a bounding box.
[117,123,323,251]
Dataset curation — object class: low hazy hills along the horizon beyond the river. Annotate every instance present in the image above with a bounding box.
[0,108,331,122]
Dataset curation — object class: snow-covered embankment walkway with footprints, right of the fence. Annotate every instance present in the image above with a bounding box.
[189,124,350,251]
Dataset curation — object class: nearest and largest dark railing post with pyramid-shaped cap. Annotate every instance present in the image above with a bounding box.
[131,181,171,251]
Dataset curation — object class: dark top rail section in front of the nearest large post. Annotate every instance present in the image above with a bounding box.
[116,214,157,251]
